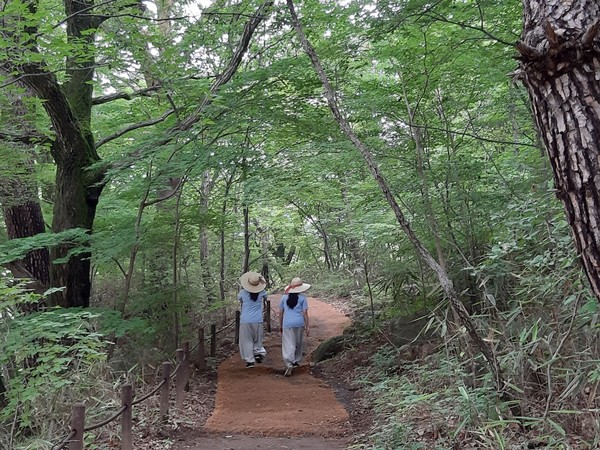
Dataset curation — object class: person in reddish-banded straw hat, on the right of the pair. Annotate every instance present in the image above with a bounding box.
[279,277,310,377]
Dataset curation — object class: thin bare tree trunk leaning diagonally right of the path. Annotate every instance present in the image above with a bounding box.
[286,0,521,416]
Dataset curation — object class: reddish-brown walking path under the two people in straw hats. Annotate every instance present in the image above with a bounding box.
[173,295,350,450]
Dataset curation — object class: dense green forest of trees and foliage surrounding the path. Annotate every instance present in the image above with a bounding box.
[0,0,600,449]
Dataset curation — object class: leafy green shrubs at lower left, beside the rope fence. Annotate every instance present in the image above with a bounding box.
[0,279,152,440]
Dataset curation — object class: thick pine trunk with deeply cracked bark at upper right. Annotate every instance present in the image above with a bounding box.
[516,0,600,300]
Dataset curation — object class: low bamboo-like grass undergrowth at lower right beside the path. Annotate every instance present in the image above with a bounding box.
[352,346,588,450]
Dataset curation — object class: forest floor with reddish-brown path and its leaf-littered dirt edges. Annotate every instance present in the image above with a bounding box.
[124,296,371,450]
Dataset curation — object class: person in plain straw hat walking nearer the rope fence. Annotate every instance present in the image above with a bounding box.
[238,272,267,368]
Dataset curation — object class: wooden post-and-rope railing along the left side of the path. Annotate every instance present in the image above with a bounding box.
[52,311,240,450]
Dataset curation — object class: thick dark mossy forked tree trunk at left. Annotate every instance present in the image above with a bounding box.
[11,0,104,307]
